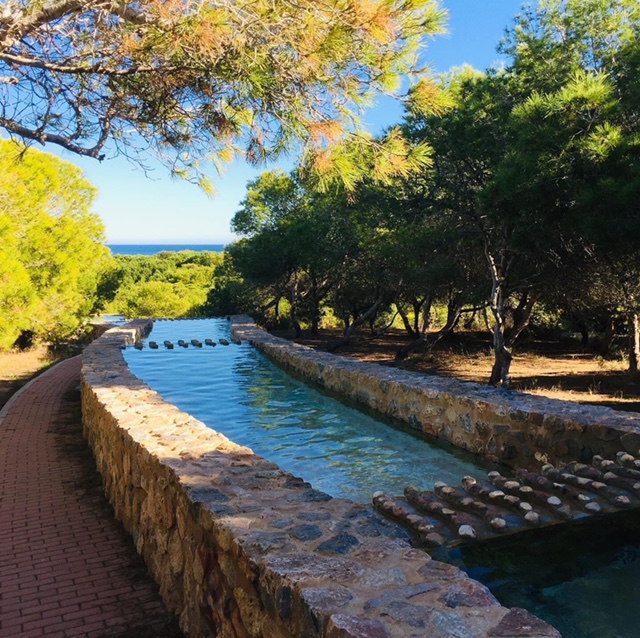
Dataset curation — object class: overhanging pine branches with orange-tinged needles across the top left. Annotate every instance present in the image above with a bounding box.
[0,0,444,188]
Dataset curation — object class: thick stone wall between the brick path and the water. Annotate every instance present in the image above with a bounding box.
[82,322,559,638]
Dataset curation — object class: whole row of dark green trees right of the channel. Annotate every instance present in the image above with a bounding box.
[218,0,640,386]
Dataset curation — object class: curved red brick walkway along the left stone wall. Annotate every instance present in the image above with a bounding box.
[0,357,182,638]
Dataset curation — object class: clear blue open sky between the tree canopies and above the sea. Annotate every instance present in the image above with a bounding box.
[44,0,522,244]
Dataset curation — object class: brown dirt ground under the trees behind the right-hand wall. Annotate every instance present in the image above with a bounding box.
[277,332,640,412]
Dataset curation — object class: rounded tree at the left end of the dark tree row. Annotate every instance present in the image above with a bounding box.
[229,171,344,334]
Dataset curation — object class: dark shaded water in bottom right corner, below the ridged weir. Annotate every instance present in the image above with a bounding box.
[442,512,640,638]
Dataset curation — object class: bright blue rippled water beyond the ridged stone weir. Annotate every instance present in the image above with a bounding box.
[125,319,492,503]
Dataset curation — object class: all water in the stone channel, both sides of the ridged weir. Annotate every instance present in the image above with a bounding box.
[125,320,640,638]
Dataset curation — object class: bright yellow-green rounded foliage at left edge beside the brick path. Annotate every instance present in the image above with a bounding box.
[0,140,109,349]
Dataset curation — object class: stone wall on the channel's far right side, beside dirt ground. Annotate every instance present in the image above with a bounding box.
[233,316,640,469]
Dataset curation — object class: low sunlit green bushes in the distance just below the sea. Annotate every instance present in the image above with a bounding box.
[103,251,223,319]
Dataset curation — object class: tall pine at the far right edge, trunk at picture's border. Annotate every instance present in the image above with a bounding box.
[493,0,640,370]
